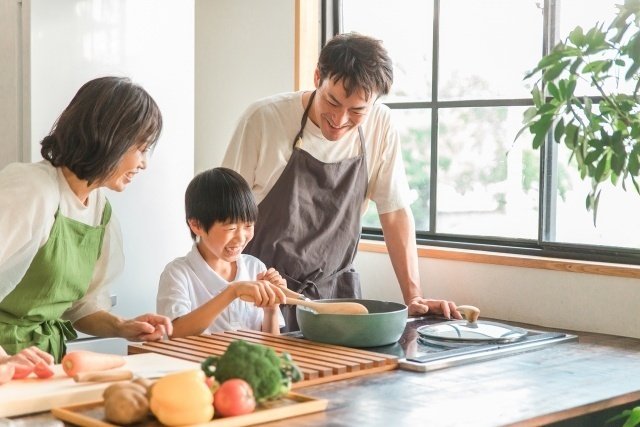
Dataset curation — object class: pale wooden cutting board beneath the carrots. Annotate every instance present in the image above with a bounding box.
[0,353,199,417]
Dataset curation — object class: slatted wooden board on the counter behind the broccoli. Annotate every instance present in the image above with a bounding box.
[128,330,398,389]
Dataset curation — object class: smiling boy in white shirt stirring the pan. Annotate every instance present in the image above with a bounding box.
[157,168,286,337]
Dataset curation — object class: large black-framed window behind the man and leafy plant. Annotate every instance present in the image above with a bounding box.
[332,0,640,263]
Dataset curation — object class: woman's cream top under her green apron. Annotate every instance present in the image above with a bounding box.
[0,160,124,322]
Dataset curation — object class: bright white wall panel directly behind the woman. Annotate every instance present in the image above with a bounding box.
[24,0,194,317]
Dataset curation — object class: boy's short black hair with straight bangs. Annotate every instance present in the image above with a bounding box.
[184,168,258,240]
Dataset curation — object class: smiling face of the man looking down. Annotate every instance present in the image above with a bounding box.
[309,70,377,141]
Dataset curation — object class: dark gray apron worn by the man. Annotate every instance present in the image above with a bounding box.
[244,92,368,331]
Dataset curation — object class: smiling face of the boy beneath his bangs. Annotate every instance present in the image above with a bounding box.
[190,222,254,264]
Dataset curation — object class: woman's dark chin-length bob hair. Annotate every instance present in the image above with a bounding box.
[40,77,162,184]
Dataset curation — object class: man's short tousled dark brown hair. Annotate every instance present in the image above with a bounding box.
[318,32,393,99]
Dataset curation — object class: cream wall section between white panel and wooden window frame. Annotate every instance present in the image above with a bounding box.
[195,0,295,172]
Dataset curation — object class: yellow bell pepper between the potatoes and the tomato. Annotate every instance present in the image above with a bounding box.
[149,369,213,426]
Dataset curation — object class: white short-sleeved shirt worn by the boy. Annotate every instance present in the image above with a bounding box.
[156,245,284,333]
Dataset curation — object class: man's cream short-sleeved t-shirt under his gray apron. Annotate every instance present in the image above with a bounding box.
[222,92,410,214]
